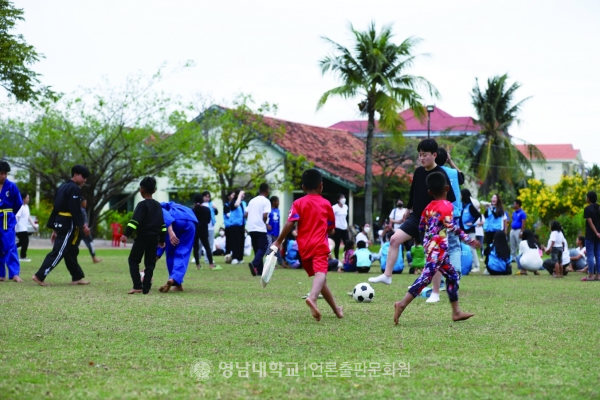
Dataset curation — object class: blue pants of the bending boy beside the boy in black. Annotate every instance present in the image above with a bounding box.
[165,221,196,285]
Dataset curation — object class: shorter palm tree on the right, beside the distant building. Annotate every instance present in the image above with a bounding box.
[459,74,544,196]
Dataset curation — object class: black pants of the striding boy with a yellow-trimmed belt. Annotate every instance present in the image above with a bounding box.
[35,215,85,282]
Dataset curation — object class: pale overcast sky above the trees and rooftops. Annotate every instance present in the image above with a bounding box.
[14,0,600,164]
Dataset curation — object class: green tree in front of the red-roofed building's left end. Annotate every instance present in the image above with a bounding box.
[169,96,311,202]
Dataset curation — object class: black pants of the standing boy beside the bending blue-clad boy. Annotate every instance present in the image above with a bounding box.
[129,235,158,293]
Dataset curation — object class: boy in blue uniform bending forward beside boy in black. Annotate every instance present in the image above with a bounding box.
[157,201,198,293]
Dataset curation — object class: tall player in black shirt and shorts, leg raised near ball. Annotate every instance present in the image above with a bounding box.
[369,139,456,285]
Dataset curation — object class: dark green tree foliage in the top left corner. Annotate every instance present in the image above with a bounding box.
[0,0,50,101]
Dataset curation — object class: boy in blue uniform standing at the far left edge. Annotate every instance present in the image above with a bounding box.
[0,161,23,282]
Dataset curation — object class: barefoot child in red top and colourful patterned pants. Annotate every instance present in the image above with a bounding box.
[394,172,479,325]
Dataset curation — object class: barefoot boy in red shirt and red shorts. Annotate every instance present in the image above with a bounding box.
[271,169,344,321]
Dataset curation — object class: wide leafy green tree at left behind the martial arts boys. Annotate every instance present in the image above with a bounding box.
[0,72,190,230]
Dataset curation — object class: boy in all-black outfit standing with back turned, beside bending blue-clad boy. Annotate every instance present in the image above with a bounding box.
[121,177,167,294]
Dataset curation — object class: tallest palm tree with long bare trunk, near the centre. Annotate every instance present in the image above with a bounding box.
[317,22,439,228]
